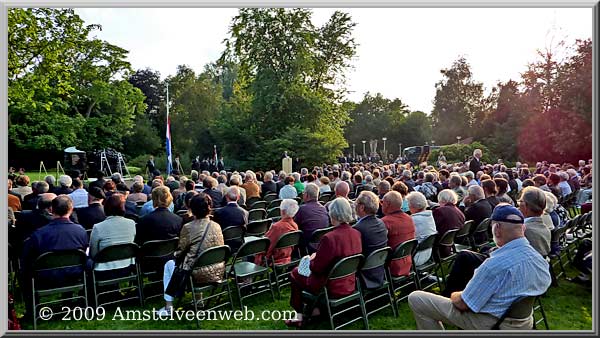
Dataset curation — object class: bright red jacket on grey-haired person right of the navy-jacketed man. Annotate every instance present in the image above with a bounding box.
[381,211,415,276]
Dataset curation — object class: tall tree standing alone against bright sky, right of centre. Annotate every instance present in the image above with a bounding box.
[431,57,485,144]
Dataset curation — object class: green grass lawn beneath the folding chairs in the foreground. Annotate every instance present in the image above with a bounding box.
[12,269,592,330]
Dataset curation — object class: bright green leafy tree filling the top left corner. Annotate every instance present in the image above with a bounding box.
[8,8,145,154]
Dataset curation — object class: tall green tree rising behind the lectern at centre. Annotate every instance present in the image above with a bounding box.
[217,8,356,168]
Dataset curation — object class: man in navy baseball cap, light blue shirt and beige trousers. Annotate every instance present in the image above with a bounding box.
[408,203,551,330]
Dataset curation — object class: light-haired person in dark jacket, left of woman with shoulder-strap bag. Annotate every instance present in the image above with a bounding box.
[135,186,183,245]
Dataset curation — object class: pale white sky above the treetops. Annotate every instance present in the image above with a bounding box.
[76,8,593,114]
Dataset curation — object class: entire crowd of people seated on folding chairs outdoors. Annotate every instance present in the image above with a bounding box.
[8,152,592,329]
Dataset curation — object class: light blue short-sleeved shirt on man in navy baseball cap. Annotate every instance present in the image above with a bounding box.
[461,237,552,318]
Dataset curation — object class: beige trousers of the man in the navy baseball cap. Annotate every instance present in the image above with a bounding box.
[408,291,533,330]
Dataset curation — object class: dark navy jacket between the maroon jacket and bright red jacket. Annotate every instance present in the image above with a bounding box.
[354,215,388,289]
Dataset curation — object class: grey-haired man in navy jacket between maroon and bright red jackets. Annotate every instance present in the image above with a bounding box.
[354,191,388,289]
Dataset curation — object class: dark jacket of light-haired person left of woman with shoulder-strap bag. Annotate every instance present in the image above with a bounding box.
[135,207,183,245]
